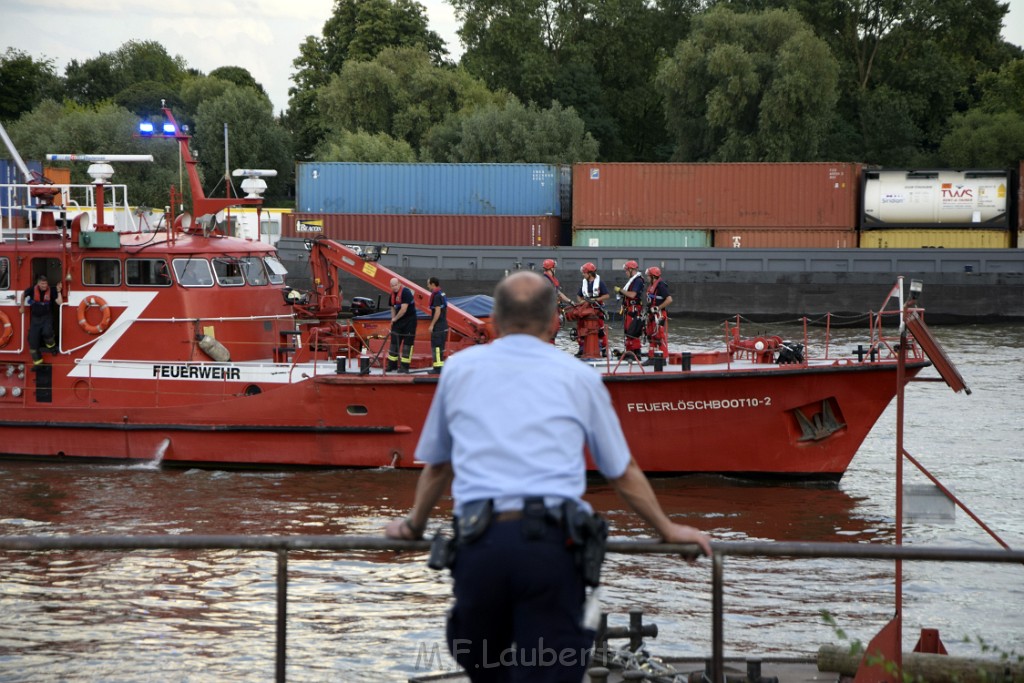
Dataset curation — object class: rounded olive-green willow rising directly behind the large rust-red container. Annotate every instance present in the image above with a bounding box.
[656,8,839,162]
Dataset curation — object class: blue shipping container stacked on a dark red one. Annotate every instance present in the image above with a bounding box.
[296,162,561,216]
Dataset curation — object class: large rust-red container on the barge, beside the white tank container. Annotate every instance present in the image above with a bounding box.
[572,163,861,229]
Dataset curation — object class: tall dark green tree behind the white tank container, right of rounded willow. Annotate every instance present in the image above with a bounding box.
[745,0,1020,165]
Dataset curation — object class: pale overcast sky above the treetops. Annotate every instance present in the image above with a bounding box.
[0,0,1024,113]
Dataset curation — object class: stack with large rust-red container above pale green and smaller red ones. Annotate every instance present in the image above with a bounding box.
[572,163,860,249]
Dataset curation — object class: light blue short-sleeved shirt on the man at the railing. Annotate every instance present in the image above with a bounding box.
[416,335,631,514]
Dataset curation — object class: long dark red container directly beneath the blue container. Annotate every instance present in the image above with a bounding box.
[281,213,561,247]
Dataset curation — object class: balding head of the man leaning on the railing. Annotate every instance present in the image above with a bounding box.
[494,270,558,340]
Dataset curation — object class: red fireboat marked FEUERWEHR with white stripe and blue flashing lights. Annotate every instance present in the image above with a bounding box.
[0,110,958,481]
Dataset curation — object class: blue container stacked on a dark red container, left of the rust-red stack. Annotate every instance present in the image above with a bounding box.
[282,162,569,247]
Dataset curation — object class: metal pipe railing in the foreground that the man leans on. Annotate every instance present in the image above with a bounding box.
[0,535,1024,682]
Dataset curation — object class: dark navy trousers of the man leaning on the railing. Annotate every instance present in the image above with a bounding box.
[447,520,594,683]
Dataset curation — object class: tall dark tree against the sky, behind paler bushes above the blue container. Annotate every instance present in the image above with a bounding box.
[286,0,447,158]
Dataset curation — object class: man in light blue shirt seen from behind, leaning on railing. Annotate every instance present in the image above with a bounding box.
[386,271,711,683]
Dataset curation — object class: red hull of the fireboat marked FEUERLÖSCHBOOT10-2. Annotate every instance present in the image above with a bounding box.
[0,362,927,480]
